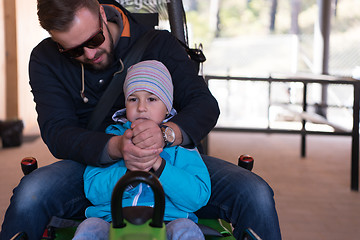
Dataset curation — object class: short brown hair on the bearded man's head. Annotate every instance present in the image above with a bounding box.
[37,0,100,32]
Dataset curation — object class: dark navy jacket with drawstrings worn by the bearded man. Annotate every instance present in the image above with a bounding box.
[29,2,219,165]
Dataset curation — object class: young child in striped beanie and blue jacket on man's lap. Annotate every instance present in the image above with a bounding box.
[74,60,211,240]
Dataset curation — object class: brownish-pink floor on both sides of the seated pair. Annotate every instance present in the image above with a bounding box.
[0,132,360,240]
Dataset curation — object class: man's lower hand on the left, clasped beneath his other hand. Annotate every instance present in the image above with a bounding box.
[108,129,162,171]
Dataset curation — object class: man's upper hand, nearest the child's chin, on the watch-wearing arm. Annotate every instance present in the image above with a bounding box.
[131,119,165,149]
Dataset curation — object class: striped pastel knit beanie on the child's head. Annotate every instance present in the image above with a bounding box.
[124,60,173,112]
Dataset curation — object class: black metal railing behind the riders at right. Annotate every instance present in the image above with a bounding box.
[204,75,360,191]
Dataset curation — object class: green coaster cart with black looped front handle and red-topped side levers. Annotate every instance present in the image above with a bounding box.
[11,155,260,240]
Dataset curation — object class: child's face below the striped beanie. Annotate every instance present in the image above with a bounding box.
[125,90,168,124]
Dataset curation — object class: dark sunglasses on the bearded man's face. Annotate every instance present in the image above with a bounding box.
[58,13,105,58]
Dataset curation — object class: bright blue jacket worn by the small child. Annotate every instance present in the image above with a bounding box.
[84,122,211,222]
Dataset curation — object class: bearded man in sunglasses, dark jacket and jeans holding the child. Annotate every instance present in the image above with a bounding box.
[0,0,281,240]
